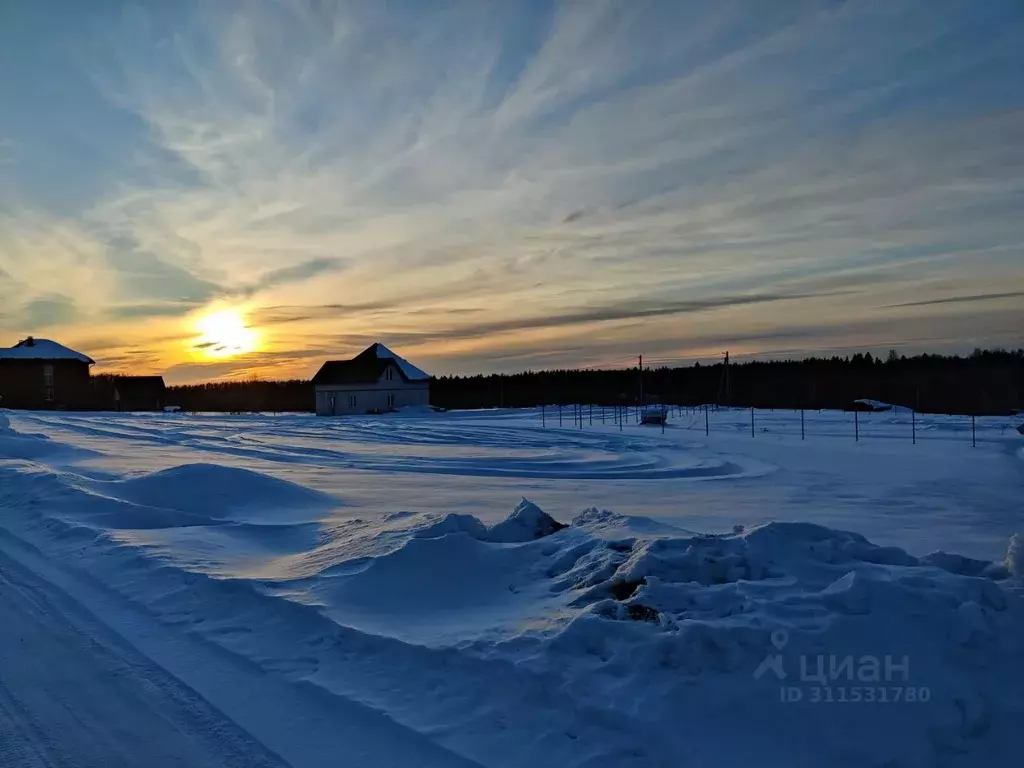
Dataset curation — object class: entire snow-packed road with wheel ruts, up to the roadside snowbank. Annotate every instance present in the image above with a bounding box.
[0,524,479,768]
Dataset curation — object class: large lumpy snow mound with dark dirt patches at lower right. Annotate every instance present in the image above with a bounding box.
[480,523,1024,766]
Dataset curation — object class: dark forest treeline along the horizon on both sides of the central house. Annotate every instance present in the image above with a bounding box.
[168,349,1024,415]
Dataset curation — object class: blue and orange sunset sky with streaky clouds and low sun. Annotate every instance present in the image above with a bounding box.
[0,0,1024,383]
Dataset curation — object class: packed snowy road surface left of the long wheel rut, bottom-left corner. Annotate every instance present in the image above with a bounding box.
[0,552,285,768]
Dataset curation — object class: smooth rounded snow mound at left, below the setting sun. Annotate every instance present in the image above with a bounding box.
[91,464,338,519]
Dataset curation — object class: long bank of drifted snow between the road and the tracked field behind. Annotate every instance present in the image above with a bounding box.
[0,414,1024,768]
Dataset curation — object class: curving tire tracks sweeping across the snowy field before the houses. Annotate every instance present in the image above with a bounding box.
[16,415,773,480]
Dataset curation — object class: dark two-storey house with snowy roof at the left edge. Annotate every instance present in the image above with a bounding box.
[0,336,93,410]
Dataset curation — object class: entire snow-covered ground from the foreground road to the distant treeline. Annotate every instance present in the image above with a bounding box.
[0,407,1024,768]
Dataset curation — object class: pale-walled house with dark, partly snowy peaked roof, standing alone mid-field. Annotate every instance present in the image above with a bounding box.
[313,344,430,416]
